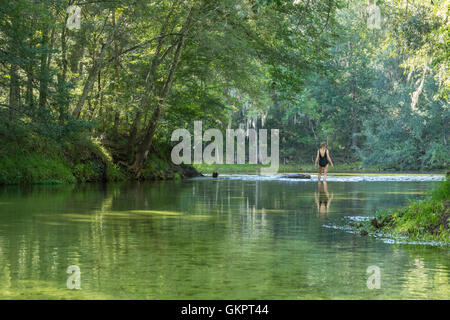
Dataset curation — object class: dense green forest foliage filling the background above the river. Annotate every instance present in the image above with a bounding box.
[0,0,450,181]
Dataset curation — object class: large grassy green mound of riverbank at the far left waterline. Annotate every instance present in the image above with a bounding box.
[0,140,124,184]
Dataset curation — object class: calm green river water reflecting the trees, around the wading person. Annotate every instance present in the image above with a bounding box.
[0,175,450,299]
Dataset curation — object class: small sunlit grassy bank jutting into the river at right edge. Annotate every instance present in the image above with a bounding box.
[353,175,450,243]
